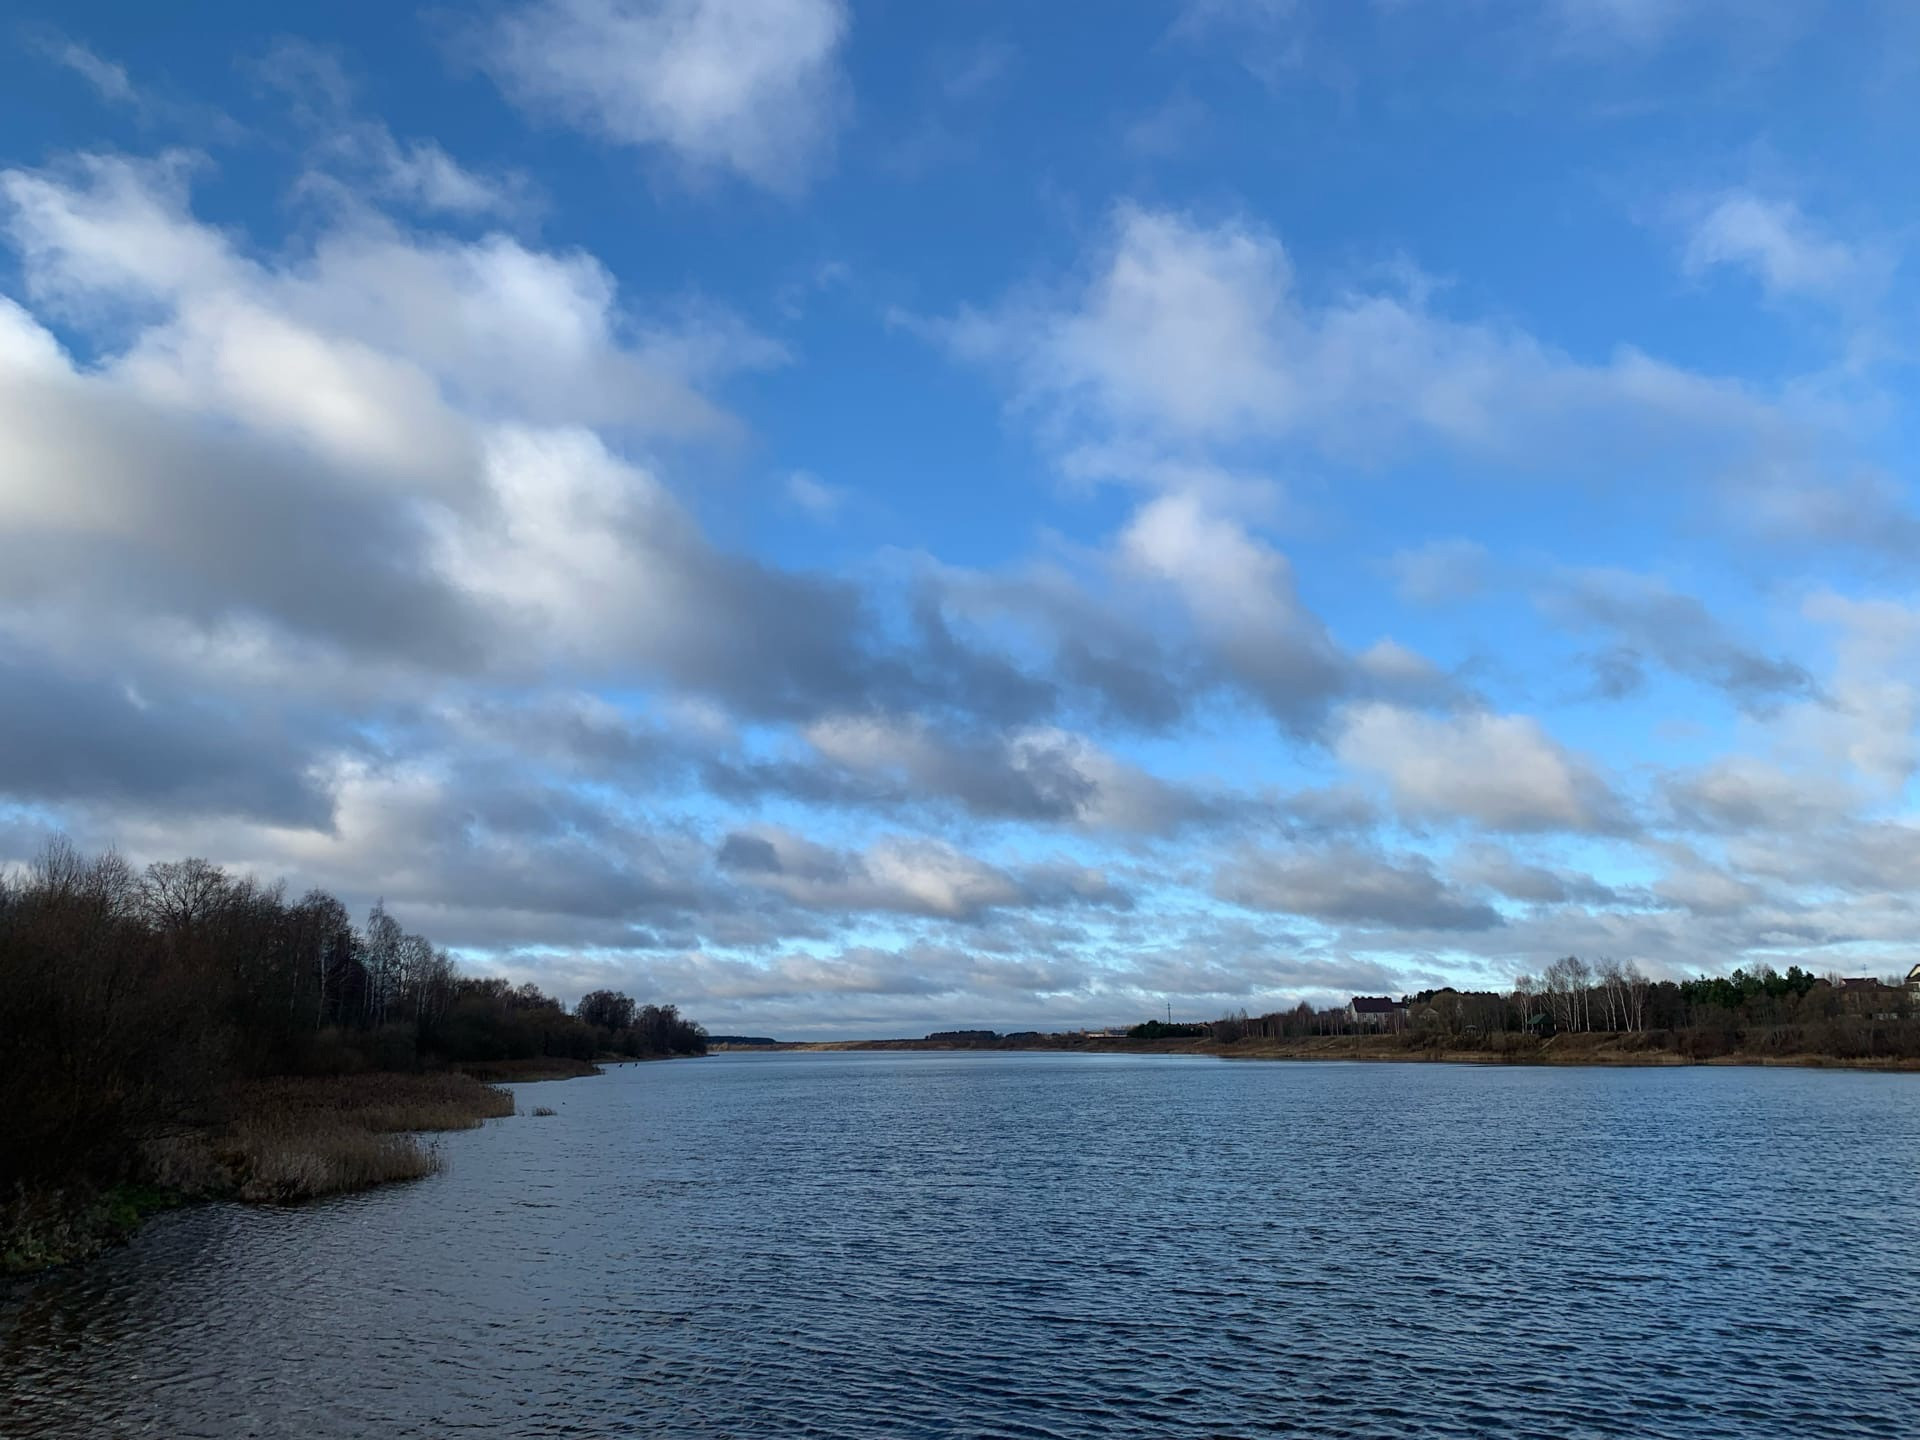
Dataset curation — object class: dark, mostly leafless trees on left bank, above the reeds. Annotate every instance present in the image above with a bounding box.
[0,841,707,1190]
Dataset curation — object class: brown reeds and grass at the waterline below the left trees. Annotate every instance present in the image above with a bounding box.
[0,1071,513,1275]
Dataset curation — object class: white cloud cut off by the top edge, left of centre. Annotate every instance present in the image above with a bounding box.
[482,0,849,194]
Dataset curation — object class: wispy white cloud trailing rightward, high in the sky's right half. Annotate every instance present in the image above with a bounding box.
[935,204,1782,467]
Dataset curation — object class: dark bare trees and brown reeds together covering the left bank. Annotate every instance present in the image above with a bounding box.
[0,843,707,1269]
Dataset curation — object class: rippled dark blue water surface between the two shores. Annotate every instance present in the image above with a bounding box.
[0,1054,1920,1440]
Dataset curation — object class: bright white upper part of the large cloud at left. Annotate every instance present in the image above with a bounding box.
[0,156,781,447]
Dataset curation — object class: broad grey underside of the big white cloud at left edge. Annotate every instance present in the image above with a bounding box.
[0,374,486,668]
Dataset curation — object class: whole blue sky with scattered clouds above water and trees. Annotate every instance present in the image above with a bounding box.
[0,0,1920,1039]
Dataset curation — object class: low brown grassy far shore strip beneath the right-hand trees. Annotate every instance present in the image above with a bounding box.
[712,1033,1920,1073]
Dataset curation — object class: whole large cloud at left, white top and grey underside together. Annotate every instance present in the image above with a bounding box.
[0,156,833,706]
